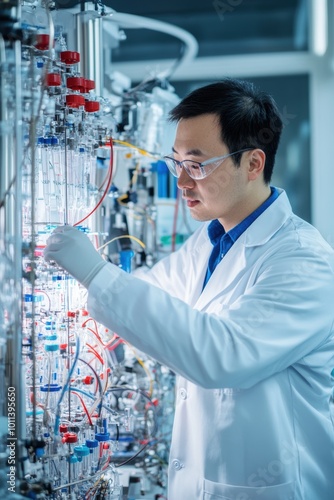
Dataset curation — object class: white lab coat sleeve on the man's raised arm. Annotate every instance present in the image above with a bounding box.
[88,249,334,388]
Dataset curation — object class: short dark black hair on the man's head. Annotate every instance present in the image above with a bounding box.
[169,78,283,184]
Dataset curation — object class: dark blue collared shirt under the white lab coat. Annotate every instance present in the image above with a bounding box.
[203,187,279,289]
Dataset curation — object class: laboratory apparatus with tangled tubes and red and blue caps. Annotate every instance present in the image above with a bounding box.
[0,0,196,500]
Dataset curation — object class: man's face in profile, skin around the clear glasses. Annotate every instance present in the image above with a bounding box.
[173,114,250,231]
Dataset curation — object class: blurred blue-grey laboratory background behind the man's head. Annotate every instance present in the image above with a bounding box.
[99,0,334,241]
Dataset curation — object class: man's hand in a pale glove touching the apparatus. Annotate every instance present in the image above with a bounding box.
[44,226,107,288]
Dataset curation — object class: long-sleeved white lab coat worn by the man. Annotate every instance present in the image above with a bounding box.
[88,191,334,500]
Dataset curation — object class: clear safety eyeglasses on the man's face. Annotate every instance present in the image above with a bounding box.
[163,148,254,180]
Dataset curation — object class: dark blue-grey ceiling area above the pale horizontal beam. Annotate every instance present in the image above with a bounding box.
[56,0,308,62]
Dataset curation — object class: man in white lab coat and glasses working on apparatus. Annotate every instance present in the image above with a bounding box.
[45,79,334,500]
